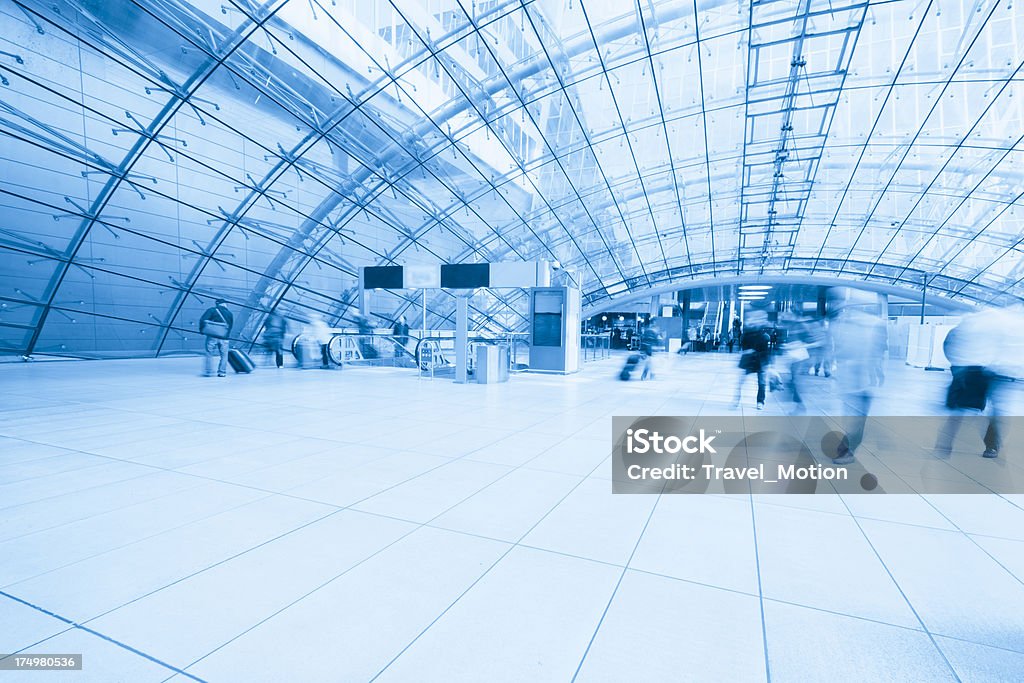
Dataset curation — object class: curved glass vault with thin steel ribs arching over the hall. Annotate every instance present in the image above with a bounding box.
[0,0,1024,355]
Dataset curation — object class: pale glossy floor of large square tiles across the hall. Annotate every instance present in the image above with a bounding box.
[0,354,1024,683]
